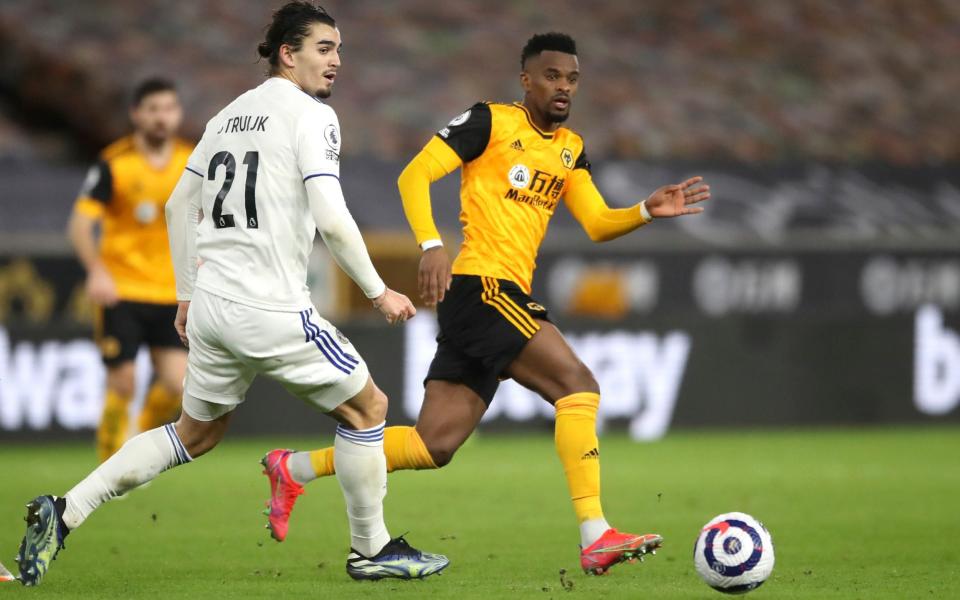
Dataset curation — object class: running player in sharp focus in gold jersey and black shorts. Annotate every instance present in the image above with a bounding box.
[266,33,710,574]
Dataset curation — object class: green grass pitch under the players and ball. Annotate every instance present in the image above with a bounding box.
[0,427,960,600]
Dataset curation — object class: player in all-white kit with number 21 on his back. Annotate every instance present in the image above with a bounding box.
[17,2,449,585]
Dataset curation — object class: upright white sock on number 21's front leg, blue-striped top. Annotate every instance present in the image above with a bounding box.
[333,422,390,558]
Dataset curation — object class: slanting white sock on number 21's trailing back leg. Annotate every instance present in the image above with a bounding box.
[63,424,193,530]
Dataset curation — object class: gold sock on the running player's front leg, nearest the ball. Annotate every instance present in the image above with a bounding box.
[554,392,603,523]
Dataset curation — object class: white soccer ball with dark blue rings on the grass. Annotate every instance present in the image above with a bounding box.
[693,512,773,594]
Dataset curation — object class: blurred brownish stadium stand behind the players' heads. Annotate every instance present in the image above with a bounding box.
[0,0,960,165]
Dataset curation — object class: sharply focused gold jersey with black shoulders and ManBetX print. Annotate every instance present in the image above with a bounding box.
[426,103,593,294]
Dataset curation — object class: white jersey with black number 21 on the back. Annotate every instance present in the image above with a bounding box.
[187,77,341,312]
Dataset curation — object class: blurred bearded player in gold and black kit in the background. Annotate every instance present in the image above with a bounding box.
[68,79,193,461]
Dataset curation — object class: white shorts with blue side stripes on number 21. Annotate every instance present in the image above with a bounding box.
[183,289,370,421]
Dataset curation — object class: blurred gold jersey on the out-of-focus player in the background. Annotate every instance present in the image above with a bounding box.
[74,136,193,304]
